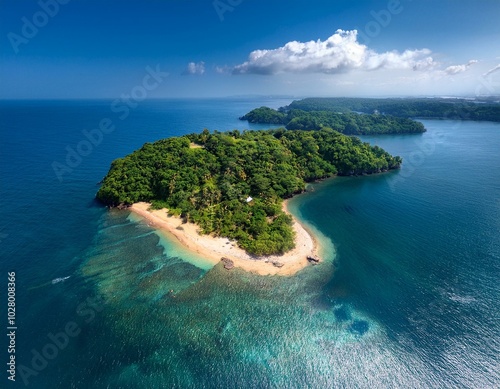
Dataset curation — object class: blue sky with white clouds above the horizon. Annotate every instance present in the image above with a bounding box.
[0,0,500,100]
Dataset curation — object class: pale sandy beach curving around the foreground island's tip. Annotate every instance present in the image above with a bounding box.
[130,201,317,276]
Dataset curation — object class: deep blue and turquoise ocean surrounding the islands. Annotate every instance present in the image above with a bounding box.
[0,98,500,389]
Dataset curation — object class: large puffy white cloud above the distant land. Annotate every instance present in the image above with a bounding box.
[232,30,437,75]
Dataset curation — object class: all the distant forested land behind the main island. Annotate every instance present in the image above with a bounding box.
[240,98,500,135]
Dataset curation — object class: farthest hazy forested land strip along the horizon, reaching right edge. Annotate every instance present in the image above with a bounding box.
[286,97,500,122]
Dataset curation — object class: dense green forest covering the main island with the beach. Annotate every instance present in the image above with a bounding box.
[97,129,402,255]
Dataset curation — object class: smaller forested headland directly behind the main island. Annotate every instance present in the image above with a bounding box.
[240,103,425,135]
